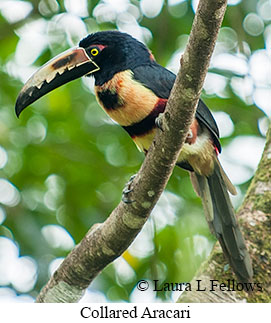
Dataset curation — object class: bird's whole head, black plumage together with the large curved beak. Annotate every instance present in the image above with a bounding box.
[15,31,151,116]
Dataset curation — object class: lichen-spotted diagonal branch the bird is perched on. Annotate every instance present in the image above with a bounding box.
[36,0,227,302]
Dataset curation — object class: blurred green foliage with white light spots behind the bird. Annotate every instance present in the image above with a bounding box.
[0,0,271,302]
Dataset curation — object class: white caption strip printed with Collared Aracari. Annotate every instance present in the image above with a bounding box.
[0,303,271,323]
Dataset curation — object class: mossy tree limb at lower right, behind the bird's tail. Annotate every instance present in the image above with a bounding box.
[178,123,271,303]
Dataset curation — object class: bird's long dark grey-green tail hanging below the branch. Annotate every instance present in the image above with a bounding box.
[191,157,253,283]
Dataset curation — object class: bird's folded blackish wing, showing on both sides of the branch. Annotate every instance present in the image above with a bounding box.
[133,62,221,152]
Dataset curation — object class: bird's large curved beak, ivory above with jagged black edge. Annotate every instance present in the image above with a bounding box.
[15,47,100,117]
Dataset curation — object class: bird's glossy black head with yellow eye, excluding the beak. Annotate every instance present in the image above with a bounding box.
[79,31,151,85]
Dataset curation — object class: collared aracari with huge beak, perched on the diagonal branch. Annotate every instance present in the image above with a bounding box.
[15,30,253,283]
